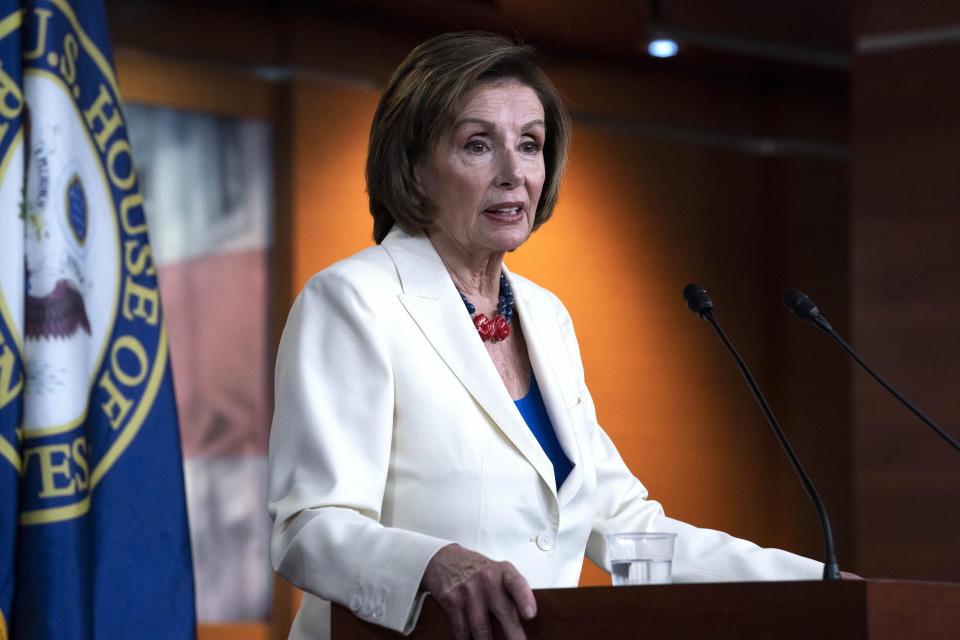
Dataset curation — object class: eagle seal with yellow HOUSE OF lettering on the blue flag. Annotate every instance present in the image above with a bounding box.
[19,0,168,525]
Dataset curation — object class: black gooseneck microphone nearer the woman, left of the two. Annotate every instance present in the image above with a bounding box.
[683,284,840,580]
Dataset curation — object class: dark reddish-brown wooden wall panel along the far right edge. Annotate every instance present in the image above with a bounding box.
[851,20,960,581]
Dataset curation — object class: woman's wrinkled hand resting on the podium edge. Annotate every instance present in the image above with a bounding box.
[420,544,537,640]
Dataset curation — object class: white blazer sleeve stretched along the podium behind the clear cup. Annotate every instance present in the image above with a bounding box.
[555,292,823,582]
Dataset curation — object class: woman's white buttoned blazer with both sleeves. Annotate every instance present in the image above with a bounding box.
[268,228,822,638]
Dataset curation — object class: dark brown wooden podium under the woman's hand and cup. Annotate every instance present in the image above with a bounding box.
[331,580,960,640]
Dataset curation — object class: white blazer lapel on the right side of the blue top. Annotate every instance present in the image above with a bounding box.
[504,268,584,506]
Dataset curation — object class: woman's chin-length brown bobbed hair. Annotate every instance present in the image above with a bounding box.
[367,32,570,244]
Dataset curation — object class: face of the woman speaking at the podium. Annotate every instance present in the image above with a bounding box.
[415,79,546,257]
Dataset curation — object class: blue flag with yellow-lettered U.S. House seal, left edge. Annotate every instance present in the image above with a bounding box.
[0,0,196,640]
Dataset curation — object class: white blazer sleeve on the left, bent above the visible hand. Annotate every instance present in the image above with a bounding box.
[268,269,448,631]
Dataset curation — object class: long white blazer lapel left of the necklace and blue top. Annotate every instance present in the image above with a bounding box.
[383,227,552,493]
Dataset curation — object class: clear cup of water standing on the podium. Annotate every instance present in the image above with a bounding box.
[604,532,677,587]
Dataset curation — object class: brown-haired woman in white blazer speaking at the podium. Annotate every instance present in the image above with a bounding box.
[270,33,822,639]
